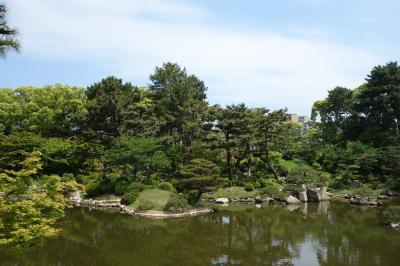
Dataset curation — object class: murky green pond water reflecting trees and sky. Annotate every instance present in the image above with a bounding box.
[0,202,400,266]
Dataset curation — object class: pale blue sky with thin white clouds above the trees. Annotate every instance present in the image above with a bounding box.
[0,0,400,114]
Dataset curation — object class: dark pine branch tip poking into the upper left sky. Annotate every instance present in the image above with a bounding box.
[0,4,20,57]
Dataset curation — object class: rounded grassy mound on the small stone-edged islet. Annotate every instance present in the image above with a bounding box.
[130,189,172,211]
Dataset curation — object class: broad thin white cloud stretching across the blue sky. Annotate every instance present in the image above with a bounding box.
[9,0,381,112]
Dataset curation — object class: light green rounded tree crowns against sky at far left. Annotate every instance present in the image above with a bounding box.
[0,84,87,136]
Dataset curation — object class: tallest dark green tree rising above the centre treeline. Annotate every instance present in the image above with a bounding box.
[150,63,207,145]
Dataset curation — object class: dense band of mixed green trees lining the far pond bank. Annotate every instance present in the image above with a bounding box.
[0,63,400,246]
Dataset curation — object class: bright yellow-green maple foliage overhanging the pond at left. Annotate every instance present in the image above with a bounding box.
[0,152,68,248]
